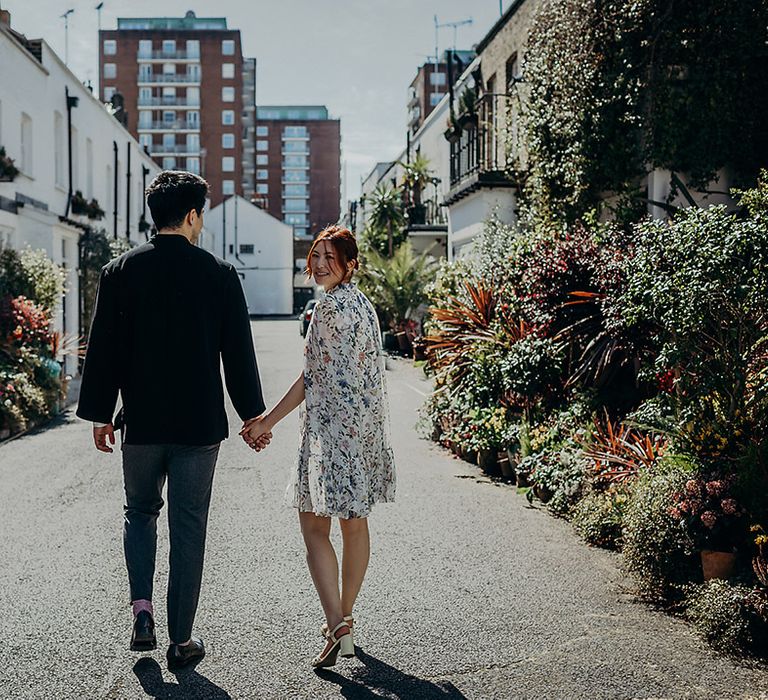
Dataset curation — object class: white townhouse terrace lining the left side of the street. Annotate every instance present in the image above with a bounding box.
[0,11,160,374]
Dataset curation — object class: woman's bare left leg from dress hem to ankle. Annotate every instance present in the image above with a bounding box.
[299,512,343,630]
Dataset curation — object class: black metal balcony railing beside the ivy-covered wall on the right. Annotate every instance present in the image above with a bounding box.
[451,94,510,187]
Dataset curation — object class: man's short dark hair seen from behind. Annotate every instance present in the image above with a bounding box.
[145,170,208,231]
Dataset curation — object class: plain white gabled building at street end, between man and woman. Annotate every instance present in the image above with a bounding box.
[203,195,294,316]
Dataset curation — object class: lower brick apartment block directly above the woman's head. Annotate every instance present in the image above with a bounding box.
[255,106,341,268]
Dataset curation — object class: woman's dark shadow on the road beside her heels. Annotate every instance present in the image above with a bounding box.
[316,647,466,700]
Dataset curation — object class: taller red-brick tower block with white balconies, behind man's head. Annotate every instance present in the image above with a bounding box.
[99,11,250,205]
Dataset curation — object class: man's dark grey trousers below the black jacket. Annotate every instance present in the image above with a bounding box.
[122,443,219,644]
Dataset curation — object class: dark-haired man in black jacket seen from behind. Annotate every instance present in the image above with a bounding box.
[77,171,268,670]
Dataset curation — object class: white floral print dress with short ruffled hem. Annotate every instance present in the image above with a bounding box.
[287,283,395,518]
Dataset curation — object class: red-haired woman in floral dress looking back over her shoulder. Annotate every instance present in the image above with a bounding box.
[241,226,395,668]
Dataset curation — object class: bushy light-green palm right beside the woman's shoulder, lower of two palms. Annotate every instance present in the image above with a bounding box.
[359,242,437,329]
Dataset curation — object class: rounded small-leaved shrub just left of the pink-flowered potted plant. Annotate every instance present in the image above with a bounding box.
[622,464,701,600]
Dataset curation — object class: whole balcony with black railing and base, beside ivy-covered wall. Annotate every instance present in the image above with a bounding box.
[445,94,517,204]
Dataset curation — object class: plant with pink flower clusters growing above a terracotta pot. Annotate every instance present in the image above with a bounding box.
[669,475,745,551]
